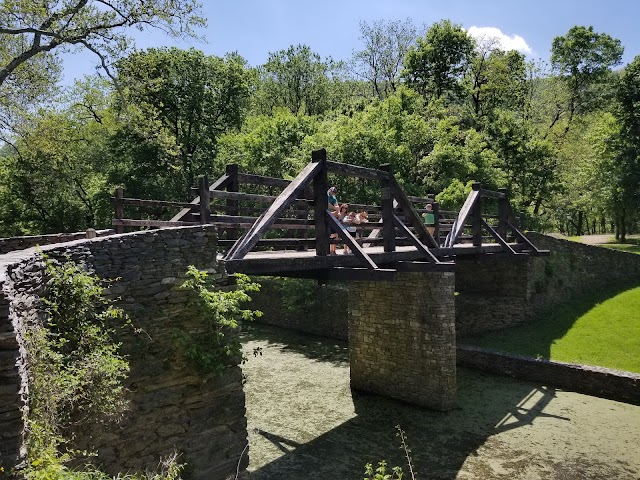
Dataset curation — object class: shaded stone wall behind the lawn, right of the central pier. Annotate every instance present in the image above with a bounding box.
[456,232,640,336]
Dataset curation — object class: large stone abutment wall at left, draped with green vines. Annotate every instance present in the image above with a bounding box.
[0,226,248,479]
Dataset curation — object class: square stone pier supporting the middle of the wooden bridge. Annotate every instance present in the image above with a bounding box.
[348,272,456,410]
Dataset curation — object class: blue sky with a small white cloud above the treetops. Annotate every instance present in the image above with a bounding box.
[63,0,640,84]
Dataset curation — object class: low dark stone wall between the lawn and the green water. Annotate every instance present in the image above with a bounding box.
[457,346,640,405]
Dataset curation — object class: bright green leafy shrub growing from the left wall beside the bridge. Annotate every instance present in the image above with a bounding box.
[176,265,262,375]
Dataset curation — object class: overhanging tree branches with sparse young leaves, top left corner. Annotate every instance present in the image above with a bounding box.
[0,0,204,147]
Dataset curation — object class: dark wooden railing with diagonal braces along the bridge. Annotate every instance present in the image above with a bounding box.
[113,150,524,262]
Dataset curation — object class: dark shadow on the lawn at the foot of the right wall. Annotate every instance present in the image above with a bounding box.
[458,284,635,360]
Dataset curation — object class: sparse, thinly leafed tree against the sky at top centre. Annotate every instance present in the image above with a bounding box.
[353,19,417,99]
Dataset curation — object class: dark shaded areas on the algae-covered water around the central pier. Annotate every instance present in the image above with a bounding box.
[248,326,569,480]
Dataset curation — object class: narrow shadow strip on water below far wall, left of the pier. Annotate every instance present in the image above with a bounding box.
[241,323,349,366]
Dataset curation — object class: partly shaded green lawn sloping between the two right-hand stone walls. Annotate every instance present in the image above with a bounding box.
[461,286,640,373]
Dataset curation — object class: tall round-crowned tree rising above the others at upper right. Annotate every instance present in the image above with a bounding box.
[551,26,624,134]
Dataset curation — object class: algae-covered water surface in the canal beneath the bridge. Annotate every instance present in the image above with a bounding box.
[244,325,640,480]
